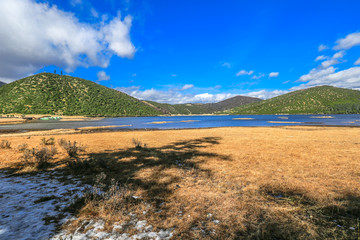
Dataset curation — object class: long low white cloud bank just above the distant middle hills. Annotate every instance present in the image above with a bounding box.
[115,87,235,104]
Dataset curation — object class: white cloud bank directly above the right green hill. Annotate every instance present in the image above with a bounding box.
[291,67,360,90]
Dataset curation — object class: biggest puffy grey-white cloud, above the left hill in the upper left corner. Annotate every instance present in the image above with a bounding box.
[0,0,135,79]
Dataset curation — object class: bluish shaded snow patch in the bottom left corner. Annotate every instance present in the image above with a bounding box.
[0,172,84,240]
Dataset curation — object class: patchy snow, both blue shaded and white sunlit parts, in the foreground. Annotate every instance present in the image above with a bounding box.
[0,171,174,240]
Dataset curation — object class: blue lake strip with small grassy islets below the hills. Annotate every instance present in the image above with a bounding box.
[0,114,360,130]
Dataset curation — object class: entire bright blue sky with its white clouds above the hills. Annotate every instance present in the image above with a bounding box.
[0,0,360,103]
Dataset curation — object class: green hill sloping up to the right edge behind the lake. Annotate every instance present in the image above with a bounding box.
[227,86,360,114]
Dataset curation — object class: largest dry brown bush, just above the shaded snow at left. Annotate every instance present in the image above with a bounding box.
[21,147,57,169]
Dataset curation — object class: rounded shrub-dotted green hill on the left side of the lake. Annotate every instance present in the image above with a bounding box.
[0,73,160,116]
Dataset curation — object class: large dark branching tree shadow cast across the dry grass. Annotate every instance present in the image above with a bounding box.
[63,137,231,218]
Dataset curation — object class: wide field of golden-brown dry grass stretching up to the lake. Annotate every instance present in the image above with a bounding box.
[0,127,360,239]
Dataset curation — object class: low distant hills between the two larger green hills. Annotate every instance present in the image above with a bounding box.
[147,96,261,114]
